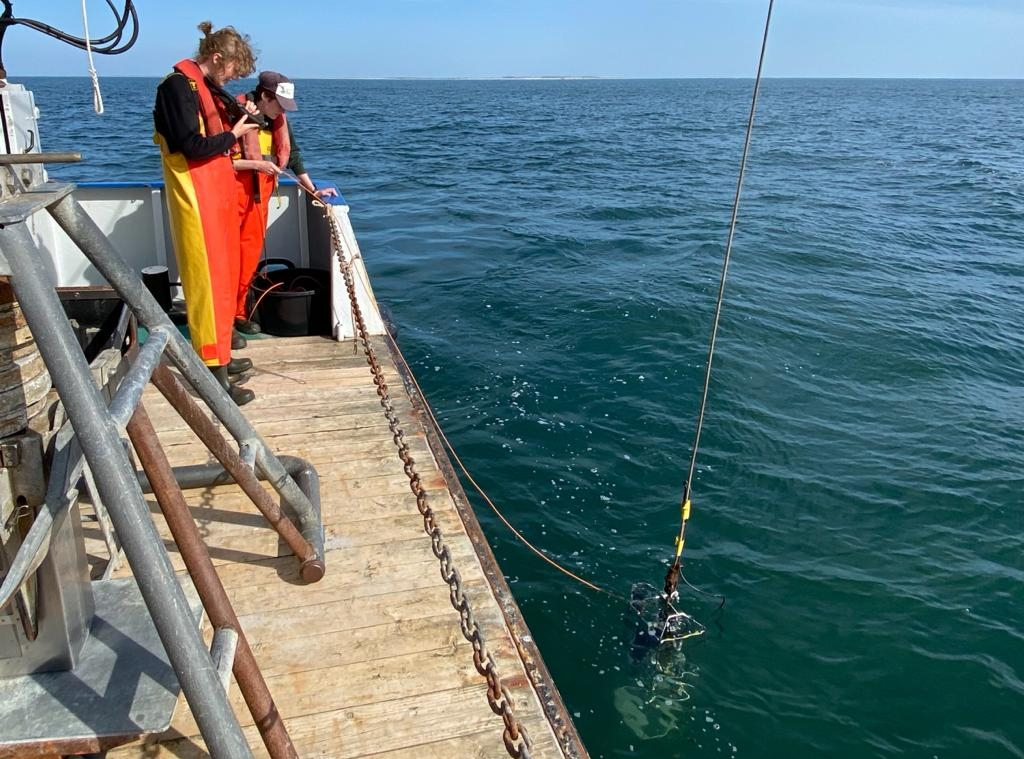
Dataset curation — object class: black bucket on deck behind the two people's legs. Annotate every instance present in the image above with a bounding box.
[249,258,331,337]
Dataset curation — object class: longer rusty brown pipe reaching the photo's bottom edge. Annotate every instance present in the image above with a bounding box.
[127,404,298,759]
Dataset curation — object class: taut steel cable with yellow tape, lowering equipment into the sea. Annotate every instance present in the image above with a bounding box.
[666,0,774,594]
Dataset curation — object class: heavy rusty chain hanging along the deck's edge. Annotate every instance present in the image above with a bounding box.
[324,204,531,759]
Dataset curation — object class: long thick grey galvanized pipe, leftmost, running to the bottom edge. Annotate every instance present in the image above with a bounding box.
[0,220,253,759]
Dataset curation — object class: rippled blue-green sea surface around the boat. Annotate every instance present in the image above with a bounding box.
[29,79,1024,759]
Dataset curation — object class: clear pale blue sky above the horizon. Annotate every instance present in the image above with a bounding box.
[3,0,1024,78]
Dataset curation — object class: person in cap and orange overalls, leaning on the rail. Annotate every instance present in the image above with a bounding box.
[232,71,337,334]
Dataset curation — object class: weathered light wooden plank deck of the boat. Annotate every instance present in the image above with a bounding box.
[96,338,587,759]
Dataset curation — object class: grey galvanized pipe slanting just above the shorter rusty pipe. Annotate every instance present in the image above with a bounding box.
[47,195,316,565]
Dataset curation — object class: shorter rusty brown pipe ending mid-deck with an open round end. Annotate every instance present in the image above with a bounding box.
[150,365,325,583]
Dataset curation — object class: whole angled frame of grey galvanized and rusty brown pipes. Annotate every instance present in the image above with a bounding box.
[0,175,325,759]
